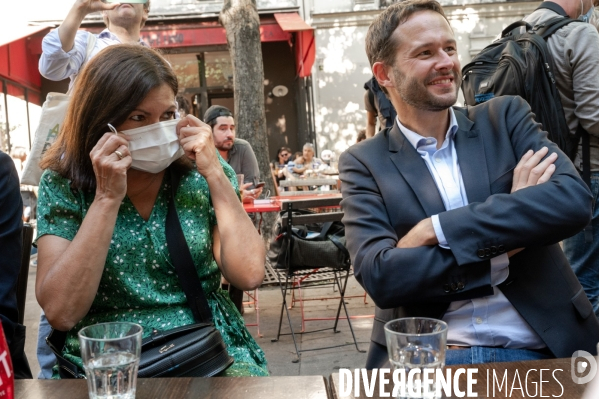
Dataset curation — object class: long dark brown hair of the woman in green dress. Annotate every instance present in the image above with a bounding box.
[40,44,183,190]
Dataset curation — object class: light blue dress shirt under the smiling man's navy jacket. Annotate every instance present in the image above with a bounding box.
[397,108,546,349]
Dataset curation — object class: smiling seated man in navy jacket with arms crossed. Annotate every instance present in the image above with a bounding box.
[339,0,599,368]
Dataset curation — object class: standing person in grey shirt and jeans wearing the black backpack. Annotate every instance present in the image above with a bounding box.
[524,0,599,316]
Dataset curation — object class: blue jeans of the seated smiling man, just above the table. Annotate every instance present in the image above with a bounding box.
[445,346,554,366]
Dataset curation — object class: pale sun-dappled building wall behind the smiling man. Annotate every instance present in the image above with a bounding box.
[305,0,540,154]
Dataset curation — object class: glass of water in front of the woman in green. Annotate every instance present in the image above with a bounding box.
[79,322,143,399]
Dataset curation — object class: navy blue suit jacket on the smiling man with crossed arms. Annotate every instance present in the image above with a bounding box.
[339,96,599,357]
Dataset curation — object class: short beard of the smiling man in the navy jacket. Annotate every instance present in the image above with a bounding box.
[393,67,462,111]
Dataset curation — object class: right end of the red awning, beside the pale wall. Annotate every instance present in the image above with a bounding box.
[274,12,316,78]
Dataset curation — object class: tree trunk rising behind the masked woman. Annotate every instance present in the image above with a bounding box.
[219,0,276,241]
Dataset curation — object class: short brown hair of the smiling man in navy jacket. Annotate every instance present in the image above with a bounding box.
[366,0,447,66]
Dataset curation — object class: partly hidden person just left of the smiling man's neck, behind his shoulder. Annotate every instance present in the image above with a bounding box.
[364,76,397,138]
